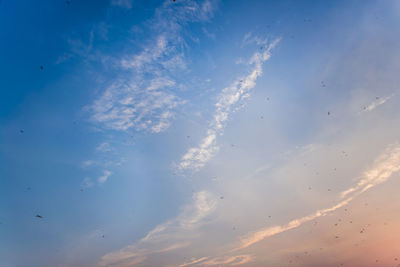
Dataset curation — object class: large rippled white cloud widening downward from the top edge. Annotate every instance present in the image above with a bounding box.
[89,0,215,133]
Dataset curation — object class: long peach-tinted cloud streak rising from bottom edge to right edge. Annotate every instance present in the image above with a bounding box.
[174,143,400,266]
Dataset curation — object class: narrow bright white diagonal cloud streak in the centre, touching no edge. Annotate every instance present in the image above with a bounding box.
[179,39,280,170]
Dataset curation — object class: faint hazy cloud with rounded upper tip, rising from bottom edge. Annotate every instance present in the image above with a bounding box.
[99,191,216,266]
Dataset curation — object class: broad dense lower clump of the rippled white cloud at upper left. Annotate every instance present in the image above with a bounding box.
[91,78,183,132]
